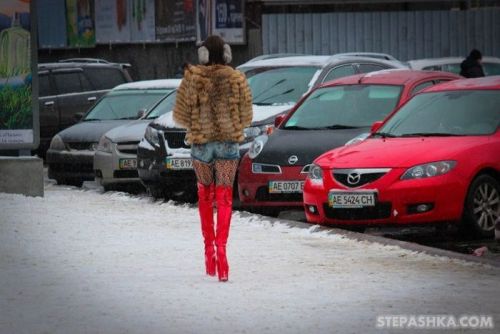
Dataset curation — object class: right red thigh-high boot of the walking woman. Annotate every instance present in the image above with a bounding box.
[215,185,233,282]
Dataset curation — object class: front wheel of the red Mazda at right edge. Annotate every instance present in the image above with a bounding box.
[463,174,500,237]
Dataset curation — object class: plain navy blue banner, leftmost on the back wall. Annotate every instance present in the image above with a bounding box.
[36,0,68,49]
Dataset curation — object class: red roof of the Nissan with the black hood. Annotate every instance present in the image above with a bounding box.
[321,69,462,87]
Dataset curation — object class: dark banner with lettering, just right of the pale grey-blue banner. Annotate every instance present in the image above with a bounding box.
[156,0,195,42]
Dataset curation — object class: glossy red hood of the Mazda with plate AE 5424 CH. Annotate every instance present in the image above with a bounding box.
[315,136,488,169]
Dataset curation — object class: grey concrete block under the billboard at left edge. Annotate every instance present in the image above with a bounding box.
[0,156,43,197]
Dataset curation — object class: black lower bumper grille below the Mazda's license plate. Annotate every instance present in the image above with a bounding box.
[323,202,392,220]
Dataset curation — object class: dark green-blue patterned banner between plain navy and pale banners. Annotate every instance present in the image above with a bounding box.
[66,0,95,47]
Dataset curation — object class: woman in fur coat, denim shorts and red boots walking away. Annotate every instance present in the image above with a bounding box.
[173,36,252,281]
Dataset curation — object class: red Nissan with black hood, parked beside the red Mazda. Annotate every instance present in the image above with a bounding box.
[238,70,461,215]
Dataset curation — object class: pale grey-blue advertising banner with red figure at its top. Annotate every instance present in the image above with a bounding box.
[95,0,155,44]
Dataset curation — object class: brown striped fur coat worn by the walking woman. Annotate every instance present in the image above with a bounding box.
[173,65,253,144]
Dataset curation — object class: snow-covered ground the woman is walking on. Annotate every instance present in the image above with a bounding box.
[0,184,500,334]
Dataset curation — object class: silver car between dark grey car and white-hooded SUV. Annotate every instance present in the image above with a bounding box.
[94,87,180,191]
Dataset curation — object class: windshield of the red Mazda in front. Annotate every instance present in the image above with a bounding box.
[374,90,500,137]
